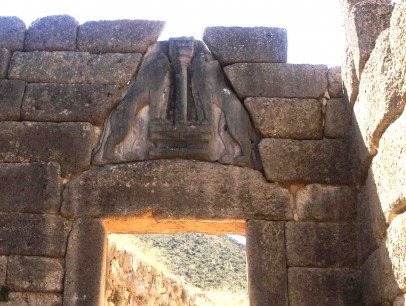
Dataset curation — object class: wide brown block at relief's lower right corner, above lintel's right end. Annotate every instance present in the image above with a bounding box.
[259,139,351,184]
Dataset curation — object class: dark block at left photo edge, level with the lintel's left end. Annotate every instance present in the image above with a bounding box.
[0,163,61,213]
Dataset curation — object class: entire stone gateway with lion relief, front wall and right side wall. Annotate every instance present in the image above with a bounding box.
[0,0,406,306]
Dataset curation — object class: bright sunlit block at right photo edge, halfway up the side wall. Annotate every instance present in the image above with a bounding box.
[369,112,406,221]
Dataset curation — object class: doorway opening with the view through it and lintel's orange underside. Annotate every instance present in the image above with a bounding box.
[105,218,249,306]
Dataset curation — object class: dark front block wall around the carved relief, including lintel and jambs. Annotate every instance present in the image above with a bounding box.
[0,12,364,305]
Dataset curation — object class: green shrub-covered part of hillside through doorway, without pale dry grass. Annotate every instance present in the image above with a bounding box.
[117,234,247,293]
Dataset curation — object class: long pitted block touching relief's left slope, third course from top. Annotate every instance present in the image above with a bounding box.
[21,84,120,126]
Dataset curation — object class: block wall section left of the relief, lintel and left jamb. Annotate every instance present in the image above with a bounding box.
[0,16,163,306]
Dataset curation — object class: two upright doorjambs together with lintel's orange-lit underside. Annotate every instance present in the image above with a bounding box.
[64,216,287,306]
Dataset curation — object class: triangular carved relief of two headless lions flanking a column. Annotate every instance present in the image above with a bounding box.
[93,37,260,168]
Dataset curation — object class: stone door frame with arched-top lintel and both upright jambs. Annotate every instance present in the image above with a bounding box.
[61,160,293,306]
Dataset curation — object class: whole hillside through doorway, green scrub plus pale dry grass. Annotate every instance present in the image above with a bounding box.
[109,234,248,306]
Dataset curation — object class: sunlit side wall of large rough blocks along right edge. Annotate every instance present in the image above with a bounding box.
[342,0,406,305]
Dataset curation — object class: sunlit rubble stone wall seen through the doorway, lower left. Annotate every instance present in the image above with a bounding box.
[106,240,213,306]
